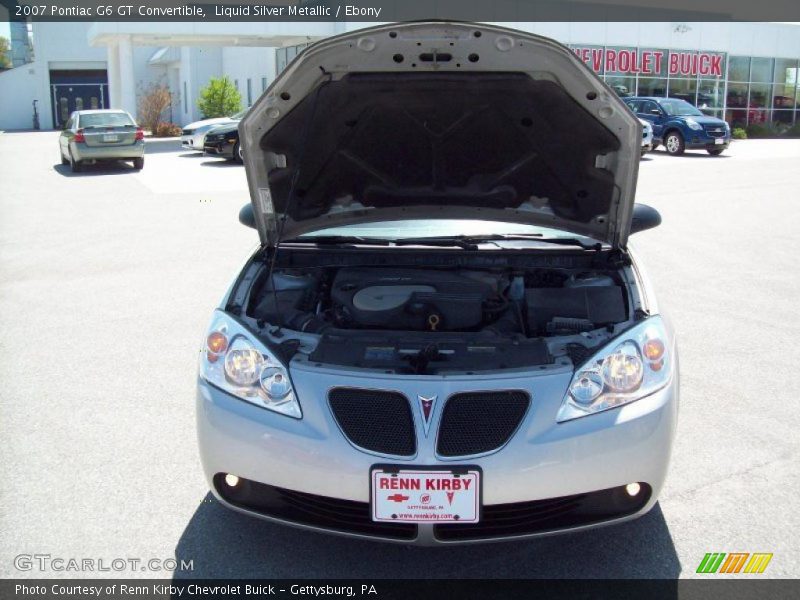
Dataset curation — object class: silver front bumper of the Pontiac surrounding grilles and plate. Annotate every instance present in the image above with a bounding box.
[197,364,678,545]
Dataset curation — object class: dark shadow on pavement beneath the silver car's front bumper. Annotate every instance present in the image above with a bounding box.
[173,494,681,579]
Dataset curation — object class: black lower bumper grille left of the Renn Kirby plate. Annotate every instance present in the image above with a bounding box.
[214,473,417,540]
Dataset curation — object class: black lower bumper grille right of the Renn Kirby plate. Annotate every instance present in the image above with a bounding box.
[433,483,652,541]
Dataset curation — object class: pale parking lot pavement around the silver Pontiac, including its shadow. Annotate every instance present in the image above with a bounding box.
[0,132,800,577]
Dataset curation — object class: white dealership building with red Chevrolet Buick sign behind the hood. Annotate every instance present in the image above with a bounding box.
[0,22,800,130]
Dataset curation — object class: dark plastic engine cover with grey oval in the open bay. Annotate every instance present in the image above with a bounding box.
[331,268,495,331]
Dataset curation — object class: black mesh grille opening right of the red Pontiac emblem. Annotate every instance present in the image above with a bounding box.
[436,390,530,456]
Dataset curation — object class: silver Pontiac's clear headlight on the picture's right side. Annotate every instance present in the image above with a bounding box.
[556,317,673,423]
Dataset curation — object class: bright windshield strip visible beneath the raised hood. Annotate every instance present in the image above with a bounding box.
[300,219,597,243]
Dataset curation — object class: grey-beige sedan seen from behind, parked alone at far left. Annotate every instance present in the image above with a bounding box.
[58,110,144,172]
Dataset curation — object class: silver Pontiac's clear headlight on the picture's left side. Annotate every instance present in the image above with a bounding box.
[200,311,303,419]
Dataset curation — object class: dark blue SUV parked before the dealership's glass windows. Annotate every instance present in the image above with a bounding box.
[622,97,731,156]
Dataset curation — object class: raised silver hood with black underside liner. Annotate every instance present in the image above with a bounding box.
[239,22,641,247]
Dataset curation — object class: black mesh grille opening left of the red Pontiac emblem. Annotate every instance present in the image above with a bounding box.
[328,388,417,456]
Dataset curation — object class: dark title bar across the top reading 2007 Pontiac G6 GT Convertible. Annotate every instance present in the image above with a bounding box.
[0,0,800,23]
